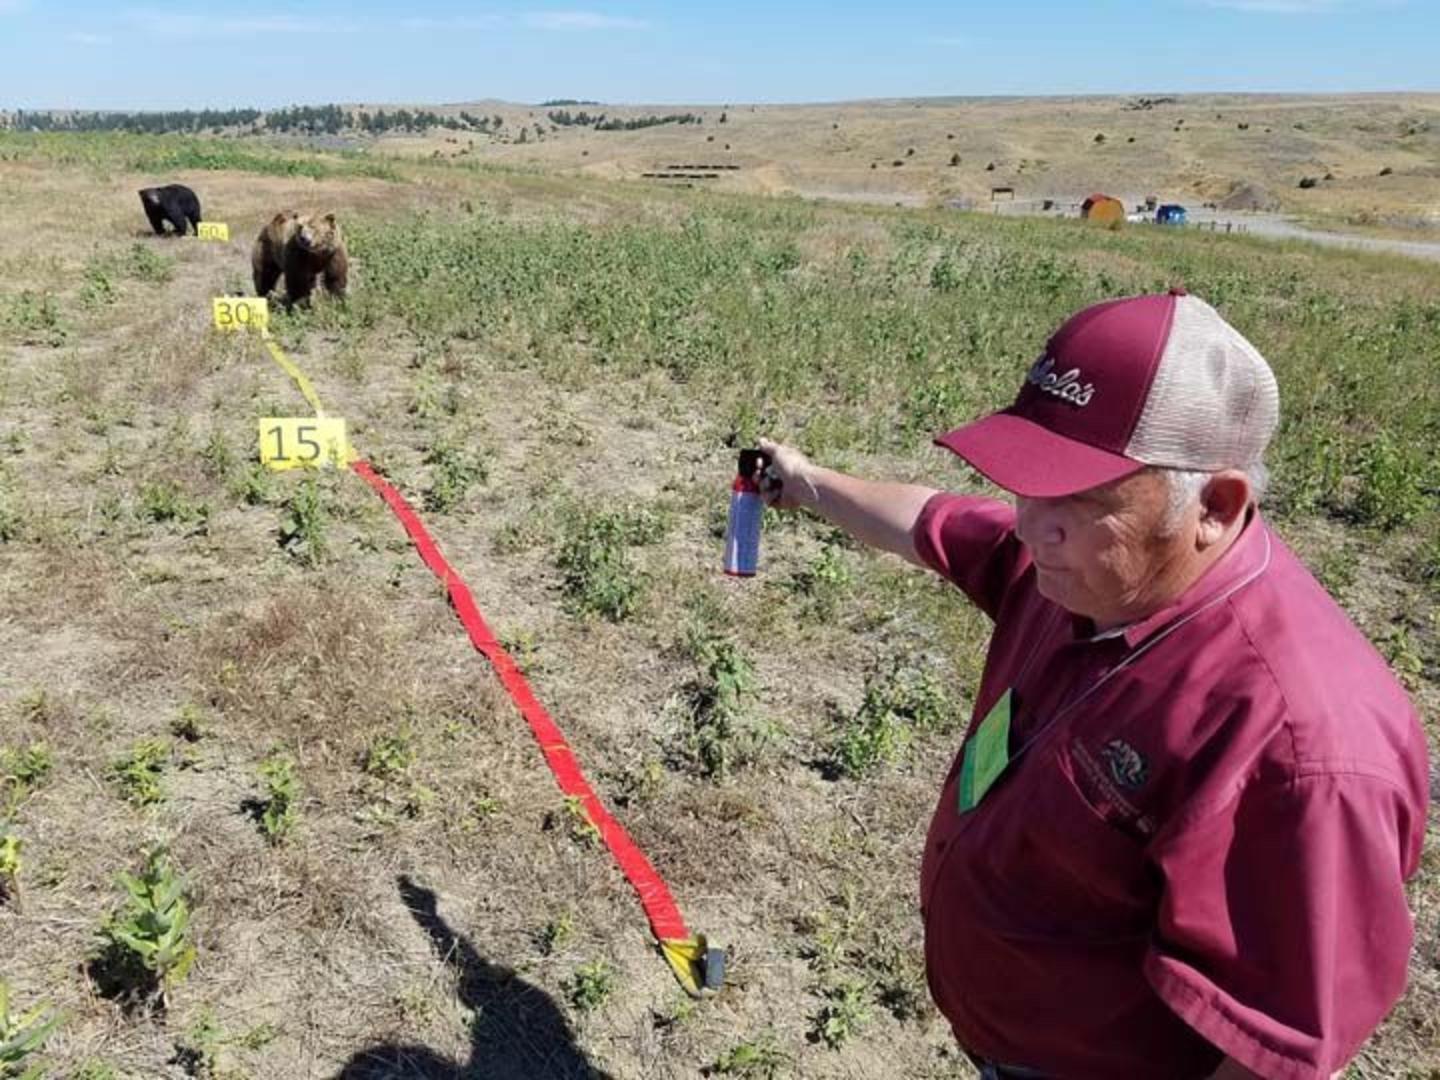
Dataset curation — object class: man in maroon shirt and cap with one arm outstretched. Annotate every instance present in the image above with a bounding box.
[762,289,1427,1080]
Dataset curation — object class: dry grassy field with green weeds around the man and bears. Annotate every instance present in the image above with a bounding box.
[0,128,1440,1080]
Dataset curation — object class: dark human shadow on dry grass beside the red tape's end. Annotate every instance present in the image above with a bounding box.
[336,874,611,1080]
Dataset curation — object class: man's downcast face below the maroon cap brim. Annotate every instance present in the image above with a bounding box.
[1015,469,1197,629]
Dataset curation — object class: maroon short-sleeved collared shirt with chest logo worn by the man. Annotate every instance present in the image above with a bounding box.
[914,494,1427,1080]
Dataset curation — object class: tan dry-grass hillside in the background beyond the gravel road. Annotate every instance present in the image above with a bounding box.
[357,94,1440,232]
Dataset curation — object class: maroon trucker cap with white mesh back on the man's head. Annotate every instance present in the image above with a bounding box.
[936,289,1280,498]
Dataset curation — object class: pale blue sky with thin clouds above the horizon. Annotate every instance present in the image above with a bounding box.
[0,0,1440,108]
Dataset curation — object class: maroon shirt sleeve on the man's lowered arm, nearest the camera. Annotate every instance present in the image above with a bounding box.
[1145,773,1424,1080]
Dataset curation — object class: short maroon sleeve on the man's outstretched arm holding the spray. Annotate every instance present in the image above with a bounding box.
[912,491,1030,619]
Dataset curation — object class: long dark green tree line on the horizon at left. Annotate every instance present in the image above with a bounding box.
[0,105,505,135]
